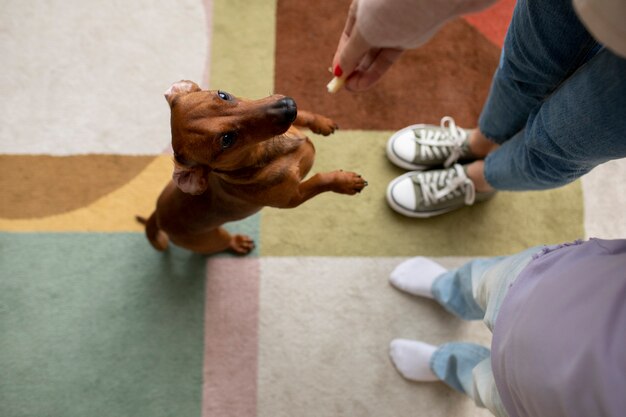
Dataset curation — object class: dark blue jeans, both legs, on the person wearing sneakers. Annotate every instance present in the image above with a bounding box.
[479,0,626,190]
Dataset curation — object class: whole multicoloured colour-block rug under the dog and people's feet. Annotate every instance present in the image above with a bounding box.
[0,0,626,417]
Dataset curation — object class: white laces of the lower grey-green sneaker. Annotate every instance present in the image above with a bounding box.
[416,164,476,206]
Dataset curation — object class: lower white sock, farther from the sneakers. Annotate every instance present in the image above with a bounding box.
[389,339,439,381]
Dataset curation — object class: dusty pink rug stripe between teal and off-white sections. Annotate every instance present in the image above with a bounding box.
[202,258,260,417]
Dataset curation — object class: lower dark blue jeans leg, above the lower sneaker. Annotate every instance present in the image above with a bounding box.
[484,49,626,190]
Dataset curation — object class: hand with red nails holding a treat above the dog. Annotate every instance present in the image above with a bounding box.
[332,0,403,91]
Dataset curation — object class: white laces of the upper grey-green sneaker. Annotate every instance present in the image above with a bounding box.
[415,116,467,168]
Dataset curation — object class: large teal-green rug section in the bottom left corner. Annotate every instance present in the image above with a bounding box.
[0,233,206,417]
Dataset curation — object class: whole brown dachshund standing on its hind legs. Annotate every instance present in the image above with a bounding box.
[138,81,367,254]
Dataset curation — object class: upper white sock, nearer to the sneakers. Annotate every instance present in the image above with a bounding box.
[389,256,447,298]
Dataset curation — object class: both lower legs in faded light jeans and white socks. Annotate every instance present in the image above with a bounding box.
[389,247,540,416]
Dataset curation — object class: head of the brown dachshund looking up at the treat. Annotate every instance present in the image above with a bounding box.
[165,81,297,194]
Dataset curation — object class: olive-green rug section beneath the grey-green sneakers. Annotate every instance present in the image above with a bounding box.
[261,130,584,256]
